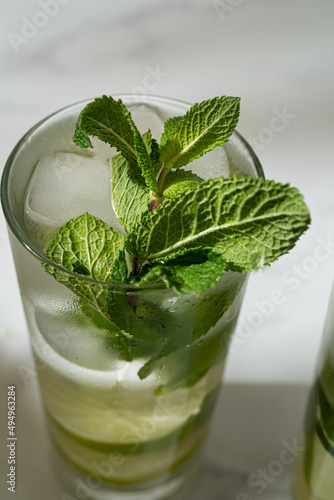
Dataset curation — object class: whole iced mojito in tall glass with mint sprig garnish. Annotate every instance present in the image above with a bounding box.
[2,95,309,500]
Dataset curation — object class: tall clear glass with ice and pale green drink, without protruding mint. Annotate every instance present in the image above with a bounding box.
[1,95,263,500]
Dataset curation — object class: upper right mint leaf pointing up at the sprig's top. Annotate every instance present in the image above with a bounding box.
[160,96,240,170]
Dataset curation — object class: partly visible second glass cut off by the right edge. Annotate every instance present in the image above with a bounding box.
[293,285,334,500]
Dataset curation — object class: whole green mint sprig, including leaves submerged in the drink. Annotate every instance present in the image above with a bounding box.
[44,96,310,386]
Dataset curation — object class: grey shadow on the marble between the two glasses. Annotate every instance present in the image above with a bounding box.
[187,384,308,500]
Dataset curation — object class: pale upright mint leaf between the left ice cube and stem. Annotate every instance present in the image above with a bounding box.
[111,155,150,232]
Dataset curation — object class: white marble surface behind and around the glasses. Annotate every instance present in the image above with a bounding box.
[0,0,334,500]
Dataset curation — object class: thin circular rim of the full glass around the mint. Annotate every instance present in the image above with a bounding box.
[0,93,264,291]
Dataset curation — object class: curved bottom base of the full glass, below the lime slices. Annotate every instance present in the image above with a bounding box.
[51,445,201,500]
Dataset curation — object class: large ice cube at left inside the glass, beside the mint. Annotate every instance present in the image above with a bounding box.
[25,153,124,250]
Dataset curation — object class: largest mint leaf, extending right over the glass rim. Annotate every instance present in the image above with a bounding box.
[126,177,310,271]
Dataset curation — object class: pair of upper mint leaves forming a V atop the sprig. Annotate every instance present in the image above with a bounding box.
[73,95,240,204]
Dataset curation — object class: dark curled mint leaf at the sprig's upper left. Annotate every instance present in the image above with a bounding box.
[73,95,157,189]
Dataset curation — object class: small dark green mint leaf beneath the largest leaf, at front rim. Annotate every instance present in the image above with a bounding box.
[136,247,226,294]
